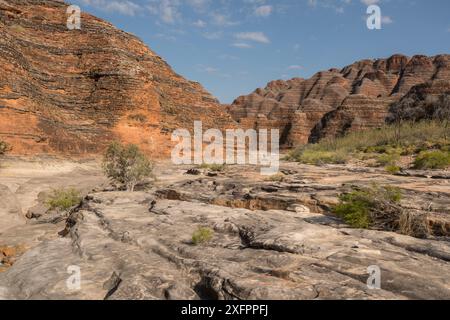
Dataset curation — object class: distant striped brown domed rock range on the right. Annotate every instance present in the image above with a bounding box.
[229,55,450,145]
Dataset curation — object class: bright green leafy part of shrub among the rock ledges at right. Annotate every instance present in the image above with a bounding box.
[332,185,402,229]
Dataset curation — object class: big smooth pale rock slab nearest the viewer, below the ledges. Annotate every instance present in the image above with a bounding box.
[0,192,450,299]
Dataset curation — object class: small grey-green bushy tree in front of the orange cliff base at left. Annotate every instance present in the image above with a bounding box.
[103,142,153,191]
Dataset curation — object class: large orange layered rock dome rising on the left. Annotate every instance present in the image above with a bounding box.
[0,0,232,155]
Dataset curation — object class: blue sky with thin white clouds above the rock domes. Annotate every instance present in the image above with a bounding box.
[69,0,450,103]
